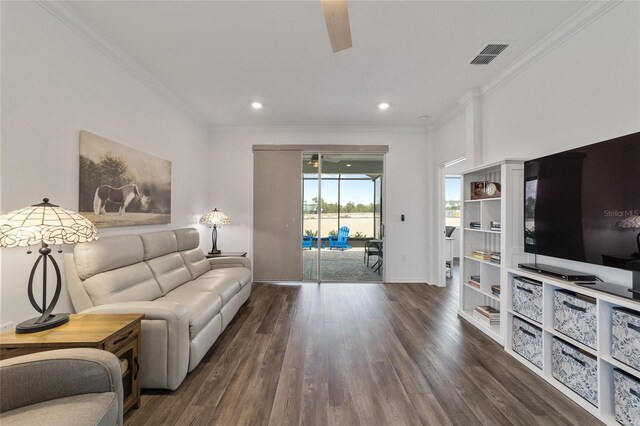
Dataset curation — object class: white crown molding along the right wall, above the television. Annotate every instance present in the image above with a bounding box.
[433,0,623,130]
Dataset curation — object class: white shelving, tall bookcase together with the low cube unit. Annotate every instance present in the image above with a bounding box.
[458,160,640,425]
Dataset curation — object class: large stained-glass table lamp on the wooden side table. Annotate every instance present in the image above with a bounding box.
[0,198,98,333]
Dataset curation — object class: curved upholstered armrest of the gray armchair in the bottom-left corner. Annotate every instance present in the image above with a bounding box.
[0,348,123,424]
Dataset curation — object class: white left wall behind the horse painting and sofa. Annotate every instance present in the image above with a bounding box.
[0,2,210,323]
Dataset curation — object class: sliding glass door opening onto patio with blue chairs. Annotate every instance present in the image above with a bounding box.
[302,152,384,282]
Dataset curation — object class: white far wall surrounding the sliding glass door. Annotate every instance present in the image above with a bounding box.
[210,128,429,282]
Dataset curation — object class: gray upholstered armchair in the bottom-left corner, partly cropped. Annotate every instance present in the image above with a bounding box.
[0,348,123,426]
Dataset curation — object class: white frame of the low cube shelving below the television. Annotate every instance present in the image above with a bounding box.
[502,268,640,425]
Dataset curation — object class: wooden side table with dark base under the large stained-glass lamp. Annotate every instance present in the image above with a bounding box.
[0,314,144,413]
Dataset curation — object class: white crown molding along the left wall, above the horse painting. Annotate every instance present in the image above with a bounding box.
[36,0,211,129]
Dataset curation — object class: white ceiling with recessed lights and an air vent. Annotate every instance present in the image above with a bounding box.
[69,0,586,127]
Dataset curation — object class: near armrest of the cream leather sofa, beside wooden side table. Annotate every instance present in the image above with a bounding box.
[81,301,190,390]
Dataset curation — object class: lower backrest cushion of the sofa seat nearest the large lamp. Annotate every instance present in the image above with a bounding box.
[83,262,162,305]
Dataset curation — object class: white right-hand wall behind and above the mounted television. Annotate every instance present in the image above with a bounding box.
[432,1,640,283]
